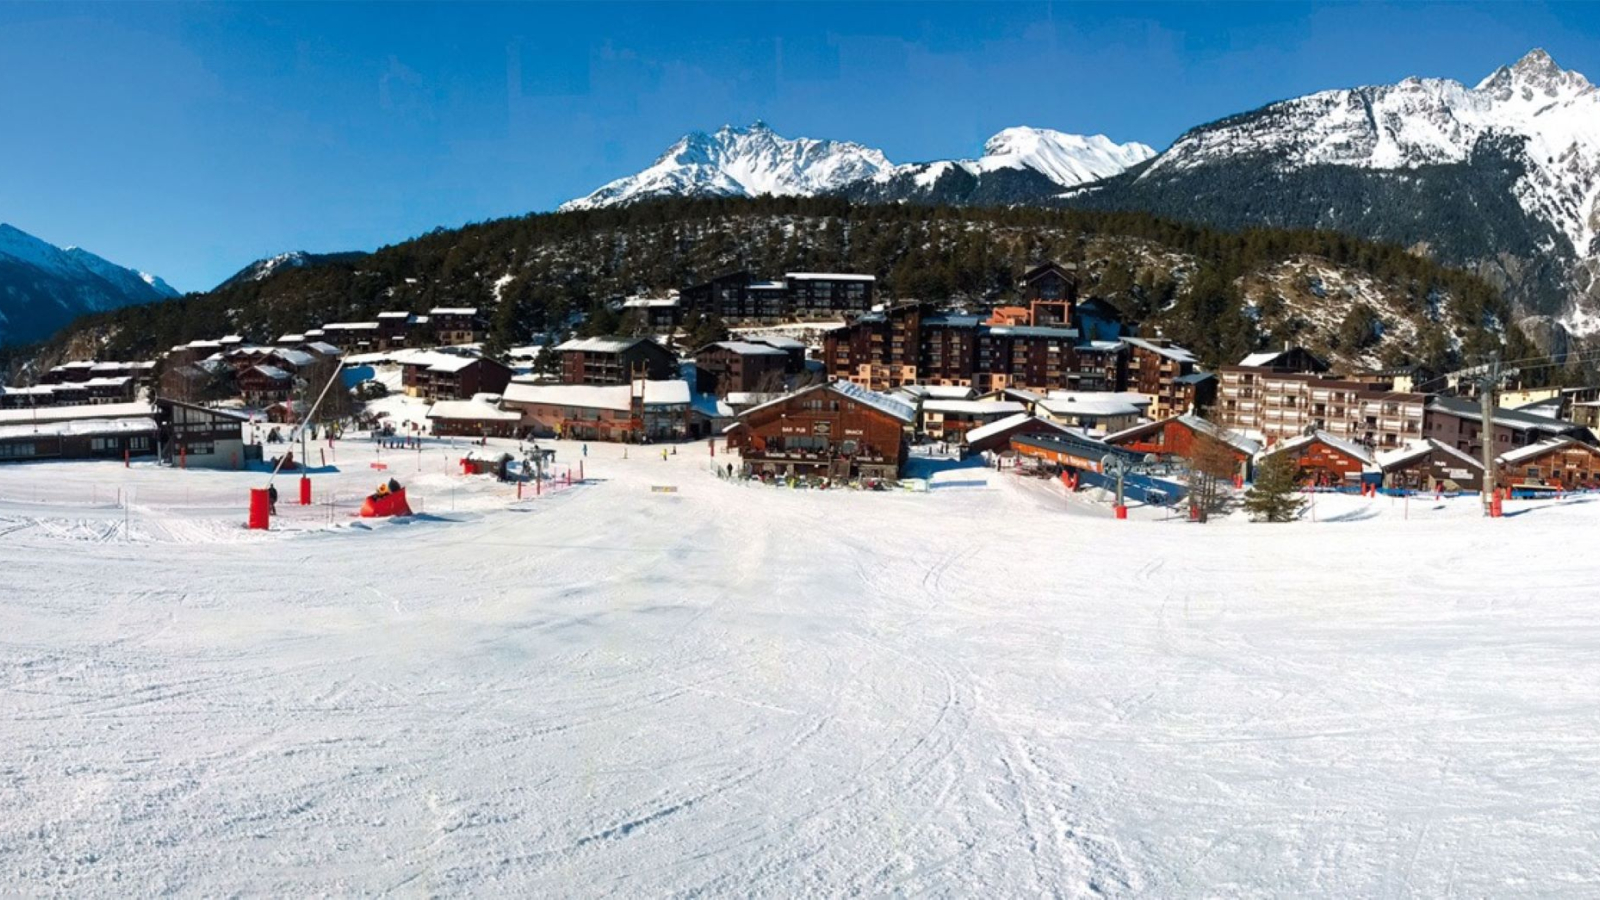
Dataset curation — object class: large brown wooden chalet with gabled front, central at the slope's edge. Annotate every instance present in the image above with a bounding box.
[728,381,917,479]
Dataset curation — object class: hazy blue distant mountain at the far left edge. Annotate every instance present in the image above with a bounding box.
[0,223,178,344]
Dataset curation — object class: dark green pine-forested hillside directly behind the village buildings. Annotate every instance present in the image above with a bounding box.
[21,197,1534,377]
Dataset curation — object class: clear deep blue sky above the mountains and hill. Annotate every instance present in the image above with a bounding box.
[0,3,1600,290]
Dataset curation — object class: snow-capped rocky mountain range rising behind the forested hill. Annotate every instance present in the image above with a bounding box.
[562,50,1600,351]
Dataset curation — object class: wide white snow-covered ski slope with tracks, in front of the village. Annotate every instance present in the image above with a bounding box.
[0,442,1600,897]
